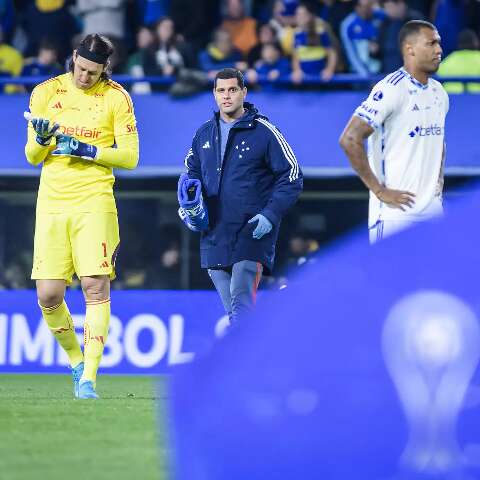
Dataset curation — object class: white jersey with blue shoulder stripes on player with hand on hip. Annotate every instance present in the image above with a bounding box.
[354,68,449,227]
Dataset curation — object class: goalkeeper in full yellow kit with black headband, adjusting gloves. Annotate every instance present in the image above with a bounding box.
[25,34,138,398]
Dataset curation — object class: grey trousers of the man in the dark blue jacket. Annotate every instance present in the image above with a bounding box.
[208,260,263,324]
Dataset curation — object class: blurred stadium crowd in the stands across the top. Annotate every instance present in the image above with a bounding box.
[0,0,480,96]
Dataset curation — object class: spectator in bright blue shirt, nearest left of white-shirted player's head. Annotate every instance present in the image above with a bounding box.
[340,0,385,76]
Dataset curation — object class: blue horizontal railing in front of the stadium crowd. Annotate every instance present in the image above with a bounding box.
[0,73,480,87]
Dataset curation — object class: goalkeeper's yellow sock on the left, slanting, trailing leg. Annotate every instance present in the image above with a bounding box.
[40,300,83,367]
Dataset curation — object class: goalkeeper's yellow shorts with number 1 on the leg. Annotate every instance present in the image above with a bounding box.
[32,213,120,284]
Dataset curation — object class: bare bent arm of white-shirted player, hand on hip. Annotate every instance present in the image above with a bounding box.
[340,115,415,210]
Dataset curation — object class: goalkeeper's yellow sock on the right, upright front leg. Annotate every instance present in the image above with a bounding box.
[80,299,110,383]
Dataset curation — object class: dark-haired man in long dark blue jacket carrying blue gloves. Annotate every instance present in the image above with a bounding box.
[179,68,303,323]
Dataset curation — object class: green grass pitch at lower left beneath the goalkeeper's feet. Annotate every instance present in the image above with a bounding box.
[0,375,171,480]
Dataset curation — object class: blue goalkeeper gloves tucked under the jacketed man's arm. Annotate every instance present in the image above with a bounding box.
[177,173,208,232]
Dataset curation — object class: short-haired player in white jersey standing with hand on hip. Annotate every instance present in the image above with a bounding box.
[340,20,449,243]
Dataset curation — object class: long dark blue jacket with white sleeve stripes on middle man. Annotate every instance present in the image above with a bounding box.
[185,102,303,274]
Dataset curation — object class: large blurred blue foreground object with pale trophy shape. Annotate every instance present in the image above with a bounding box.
[172,182,480,480]
